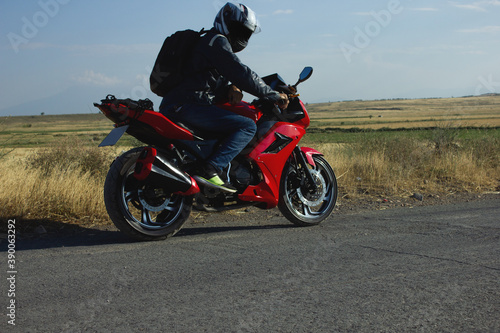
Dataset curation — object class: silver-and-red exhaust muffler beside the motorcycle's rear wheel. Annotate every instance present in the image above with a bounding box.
[134,147,200,195]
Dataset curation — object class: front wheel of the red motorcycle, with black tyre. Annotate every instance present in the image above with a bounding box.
[278,156,337,226]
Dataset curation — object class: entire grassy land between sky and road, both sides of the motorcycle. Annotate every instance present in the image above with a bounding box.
[0,96,500,224]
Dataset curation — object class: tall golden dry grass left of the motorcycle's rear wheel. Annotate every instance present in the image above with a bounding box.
[0,140,120,229]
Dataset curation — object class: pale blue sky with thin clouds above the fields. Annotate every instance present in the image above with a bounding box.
[0,0,500,115]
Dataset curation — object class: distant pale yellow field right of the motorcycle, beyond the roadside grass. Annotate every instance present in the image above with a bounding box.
[308,95,500,129]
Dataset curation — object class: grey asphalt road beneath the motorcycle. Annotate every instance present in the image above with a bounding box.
[0,199,500,332]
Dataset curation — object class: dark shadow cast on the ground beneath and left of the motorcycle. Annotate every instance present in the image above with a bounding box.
[0,220,294,251]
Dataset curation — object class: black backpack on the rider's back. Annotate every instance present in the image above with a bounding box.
[149,29,206,97]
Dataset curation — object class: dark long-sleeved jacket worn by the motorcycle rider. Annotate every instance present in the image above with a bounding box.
[160,29,280,109]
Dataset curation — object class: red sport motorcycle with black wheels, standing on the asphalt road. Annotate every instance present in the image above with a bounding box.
[94,67,337,240]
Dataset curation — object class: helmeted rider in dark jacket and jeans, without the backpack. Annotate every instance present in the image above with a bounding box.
[160,2,288,193]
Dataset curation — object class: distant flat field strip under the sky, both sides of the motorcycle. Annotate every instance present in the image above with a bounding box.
[0,95,500,148]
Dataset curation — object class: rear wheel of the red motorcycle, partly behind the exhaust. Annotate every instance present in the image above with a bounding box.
[104,148,193,241]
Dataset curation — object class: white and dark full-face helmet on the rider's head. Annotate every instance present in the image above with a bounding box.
[214,2,260,53]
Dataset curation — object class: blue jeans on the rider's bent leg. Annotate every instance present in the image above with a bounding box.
[160,104,257,172]
